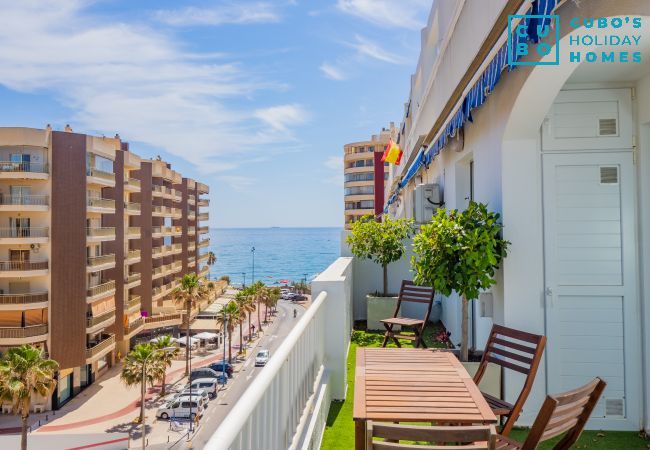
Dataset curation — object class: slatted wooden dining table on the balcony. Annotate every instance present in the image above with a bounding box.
[353,348,497,450]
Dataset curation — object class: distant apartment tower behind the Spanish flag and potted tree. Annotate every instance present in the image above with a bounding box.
[343,123,397,229]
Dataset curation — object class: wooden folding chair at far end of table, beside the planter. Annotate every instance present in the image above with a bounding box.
[381,280,435,348]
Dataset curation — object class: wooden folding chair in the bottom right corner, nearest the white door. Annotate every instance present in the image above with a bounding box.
[496,378,607,450]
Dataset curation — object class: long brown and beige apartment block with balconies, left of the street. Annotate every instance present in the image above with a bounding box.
[0,126,209,409]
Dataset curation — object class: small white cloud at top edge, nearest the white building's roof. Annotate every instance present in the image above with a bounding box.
[336,0,432,29]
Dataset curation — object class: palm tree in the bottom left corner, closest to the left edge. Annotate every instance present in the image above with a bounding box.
[0,345,59,450]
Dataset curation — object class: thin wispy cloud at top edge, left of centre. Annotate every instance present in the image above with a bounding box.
[154,2,280,26]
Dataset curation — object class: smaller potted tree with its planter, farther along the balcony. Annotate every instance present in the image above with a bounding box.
[346,216,413,330]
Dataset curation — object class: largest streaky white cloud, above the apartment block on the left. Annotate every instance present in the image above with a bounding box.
[0,0,308,173]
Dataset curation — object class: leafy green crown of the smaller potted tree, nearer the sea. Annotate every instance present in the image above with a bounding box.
[346,216,413,267]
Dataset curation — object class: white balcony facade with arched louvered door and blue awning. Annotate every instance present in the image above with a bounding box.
[385,0,650,430]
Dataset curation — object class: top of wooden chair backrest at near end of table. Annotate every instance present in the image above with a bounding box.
[366,420,496,450]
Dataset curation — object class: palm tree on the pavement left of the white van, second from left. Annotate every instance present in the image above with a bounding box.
[120,344,166,424]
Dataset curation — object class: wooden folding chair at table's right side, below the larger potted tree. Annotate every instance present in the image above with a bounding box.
[474,325,546,436]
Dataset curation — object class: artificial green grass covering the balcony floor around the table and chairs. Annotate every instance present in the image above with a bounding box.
[321,331,650,450]
